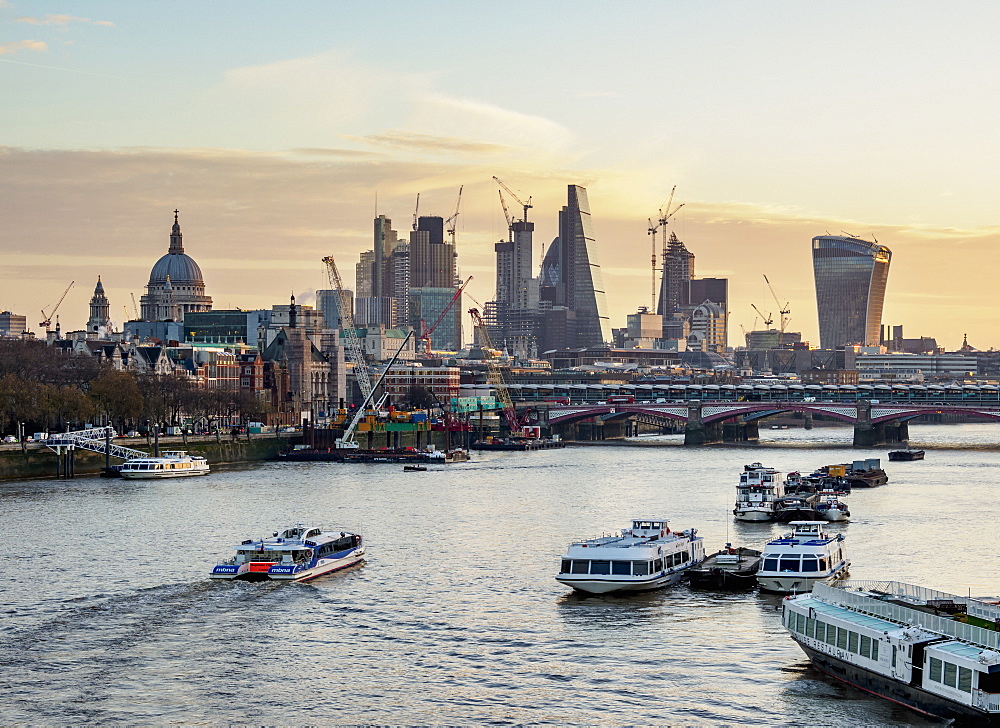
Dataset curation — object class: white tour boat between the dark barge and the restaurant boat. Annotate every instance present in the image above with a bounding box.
[757,521,851,594]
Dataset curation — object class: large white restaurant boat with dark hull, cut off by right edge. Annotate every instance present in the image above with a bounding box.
[783,581,1000,725]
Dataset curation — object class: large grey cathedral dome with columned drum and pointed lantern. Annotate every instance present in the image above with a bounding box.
[140,210,212,321]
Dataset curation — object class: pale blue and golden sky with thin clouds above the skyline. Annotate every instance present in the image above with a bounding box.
[0,0,1000,349]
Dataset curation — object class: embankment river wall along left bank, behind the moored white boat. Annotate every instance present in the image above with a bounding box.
[0,435,299,480]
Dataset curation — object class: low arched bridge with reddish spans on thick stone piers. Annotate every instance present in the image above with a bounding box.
[518,400,1000,447]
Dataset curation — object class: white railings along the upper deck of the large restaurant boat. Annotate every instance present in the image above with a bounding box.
[813,581,1000,649]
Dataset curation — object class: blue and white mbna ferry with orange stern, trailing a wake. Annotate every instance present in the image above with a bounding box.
[210,524,365,581]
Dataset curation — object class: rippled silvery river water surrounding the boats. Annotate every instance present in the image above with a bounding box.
[0,424,1000,726]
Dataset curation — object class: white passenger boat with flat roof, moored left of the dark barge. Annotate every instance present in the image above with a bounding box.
[556,518,705,594]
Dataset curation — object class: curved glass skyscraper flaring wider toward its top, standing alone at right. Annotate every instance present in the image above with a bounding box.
[812,235,892,349]
